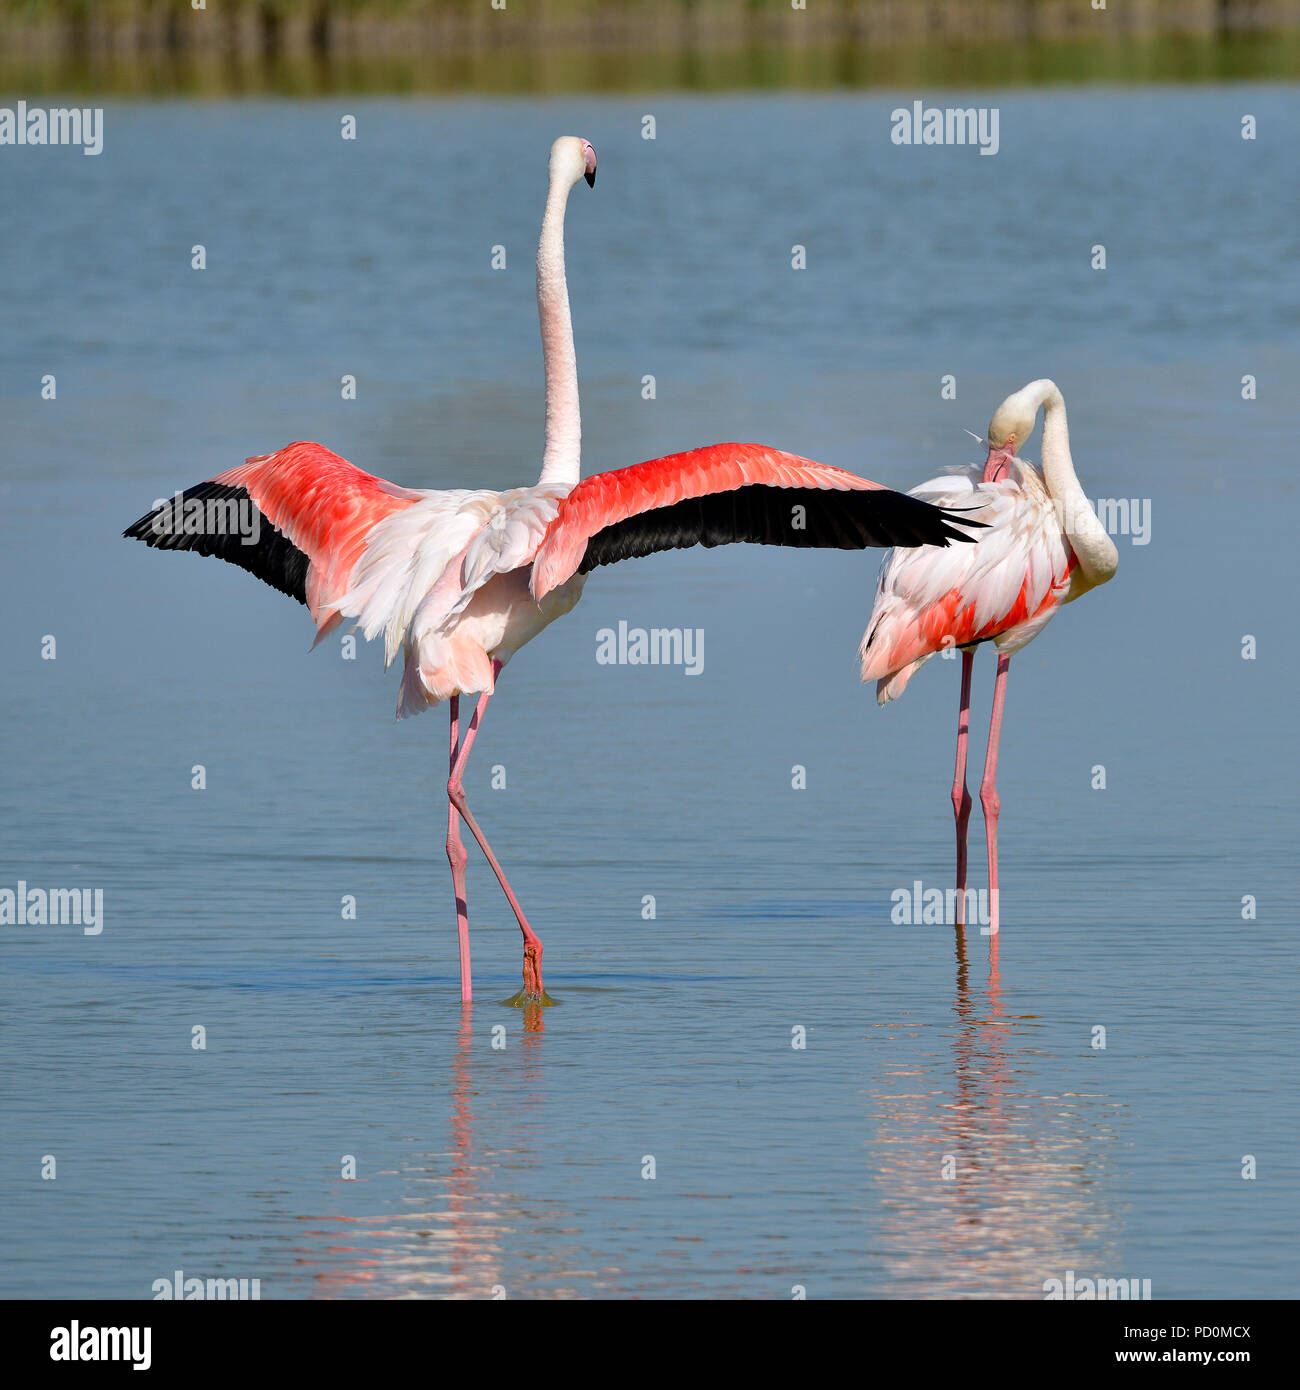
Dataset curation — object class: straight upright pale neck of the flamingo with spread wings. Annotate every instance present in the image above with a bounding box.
[537,178,583,485]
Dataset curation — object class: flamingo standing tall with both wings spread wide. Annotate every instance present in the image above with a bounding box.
[125,136,977,1005]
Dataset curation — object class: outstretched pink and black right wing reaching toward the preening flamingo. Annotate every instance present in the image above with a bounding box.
[533,443,977,599]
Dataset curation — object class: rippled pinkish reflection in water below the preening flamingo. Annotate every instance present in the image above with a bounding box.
[875,927,1116,1298]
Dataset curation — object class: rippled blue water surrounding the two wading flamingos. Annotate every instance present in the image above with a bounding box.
[0,86,1300,1298]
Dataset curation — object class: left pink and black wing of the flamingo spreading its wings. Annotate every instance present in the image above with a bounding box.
[122,442,424,641]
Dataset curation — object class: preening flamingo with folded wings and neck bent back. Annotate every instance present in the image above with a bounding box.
[858,378,1119,934]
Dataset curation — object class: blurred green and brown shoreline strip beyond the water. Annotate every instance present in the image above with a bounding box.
[0,0,1300,96]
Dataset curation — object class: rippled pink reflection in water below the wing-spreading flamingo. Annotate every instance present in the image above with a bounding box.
[298,1004,592,1298]
